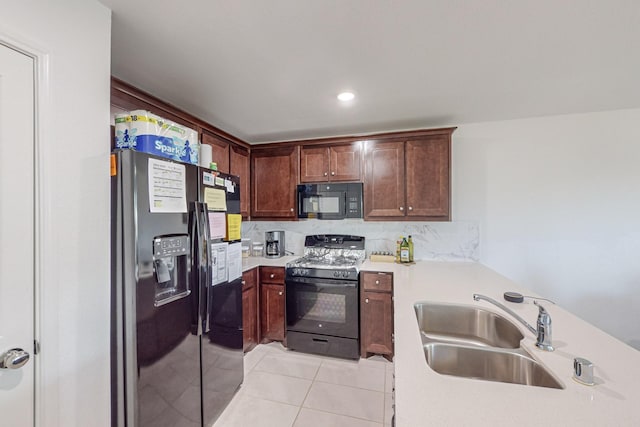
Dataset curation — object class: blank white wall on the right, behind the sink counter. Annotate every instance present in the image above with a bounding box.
[453,109,640,349]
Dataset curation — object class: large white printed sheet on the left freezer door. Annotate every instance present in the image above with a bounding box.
[147,158,187,213]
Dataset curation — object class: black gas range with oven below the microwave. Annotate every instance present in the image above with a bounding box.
[285,234,365,359]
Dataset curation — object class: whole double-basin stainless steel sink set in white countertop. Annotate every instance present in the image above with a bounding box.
[414,302,564,389]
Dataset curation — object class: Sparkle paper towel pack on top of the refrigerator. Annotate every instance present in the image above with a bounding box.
[115,110,200,165]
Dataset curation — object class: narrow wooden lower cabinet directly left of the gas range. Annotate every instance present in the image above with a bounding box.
[260,267,286,342]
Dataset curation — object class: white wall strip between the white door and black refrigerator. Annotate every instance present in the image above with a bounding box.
[0,0,111,426]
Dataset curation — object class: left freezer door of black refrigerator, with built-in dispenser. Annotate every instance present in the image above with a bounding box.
[112,150,202,426]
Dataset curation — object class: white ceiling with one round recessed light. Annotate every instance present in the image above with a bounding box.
[101,0,640,143]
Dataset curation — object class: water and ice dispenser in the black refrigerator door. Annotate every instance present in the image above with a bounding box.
[153,234,191,307]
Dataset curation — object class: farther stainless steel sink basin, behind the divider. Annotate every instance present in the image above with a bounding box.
[414,302,524,348]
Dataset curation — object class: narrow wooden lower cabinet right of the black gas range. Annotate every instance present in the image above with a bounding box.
[360,271,393,361]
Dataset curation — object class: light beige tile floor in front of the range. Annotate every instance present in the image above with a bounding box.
[214,343,393,427]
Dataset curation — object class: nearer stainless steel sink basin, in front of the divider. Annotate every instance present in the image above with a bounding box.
[424,342,564,389]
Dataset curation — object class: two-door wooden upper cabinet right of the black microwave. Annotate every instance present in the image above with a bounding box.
[364,128,454,221]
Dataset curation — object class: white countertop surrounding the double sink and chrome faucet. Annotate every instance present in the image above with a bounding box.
[361,261,640,427]
